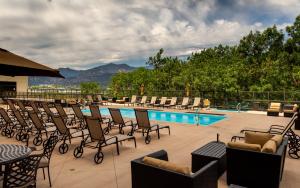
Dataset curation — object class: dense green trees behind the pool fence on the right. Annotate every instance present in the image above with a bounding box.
[110,15,300,96]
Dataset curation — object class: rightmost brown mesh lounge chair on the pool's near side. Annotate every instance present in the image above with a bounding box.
[132,109,170,144]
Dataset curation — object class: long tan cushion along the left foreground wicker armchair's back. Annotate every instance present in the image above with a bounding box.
[143,156,191,175]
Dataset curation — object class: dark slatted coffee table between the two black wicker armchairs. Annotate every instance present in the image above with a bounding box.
[192,141,226,177]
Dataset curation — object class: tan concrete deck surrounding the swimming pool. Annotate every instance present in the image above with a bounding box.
[0,105,300,188]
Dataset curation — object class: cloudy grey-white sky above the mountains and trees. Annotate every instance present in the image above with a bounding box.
[0,0,300,69]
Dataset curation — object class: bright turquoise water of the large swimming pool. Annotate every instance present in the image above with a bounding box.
[83,108,226,126]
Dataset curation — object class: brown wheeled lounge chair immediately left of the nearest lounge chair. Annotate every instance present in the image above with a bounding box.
[52,115,87,154]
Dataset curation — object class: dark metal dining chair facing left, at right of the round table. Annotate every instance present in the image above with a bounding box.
[30,135,59,187]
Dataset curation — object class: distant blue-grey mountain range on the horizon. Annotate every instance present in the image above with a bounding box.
[29,63,136,86]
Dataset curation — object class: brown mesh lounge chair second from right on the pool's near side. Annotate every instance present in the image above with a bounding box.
[108,108,133,134]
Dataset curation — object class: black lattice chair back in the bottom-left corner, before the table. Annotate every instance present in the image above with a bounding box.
[3,155,42,187]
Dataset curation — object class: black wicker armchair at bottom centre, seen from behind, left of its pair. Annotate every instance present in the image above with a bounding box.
[131,150,218,188]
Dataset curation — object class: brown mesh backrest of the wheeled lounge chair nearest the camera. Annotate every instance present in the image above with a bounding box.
[84,116,105,143]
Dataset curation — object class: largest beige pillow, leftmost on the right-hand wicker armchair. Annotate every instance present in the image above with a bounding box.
[245,131,273,147]
